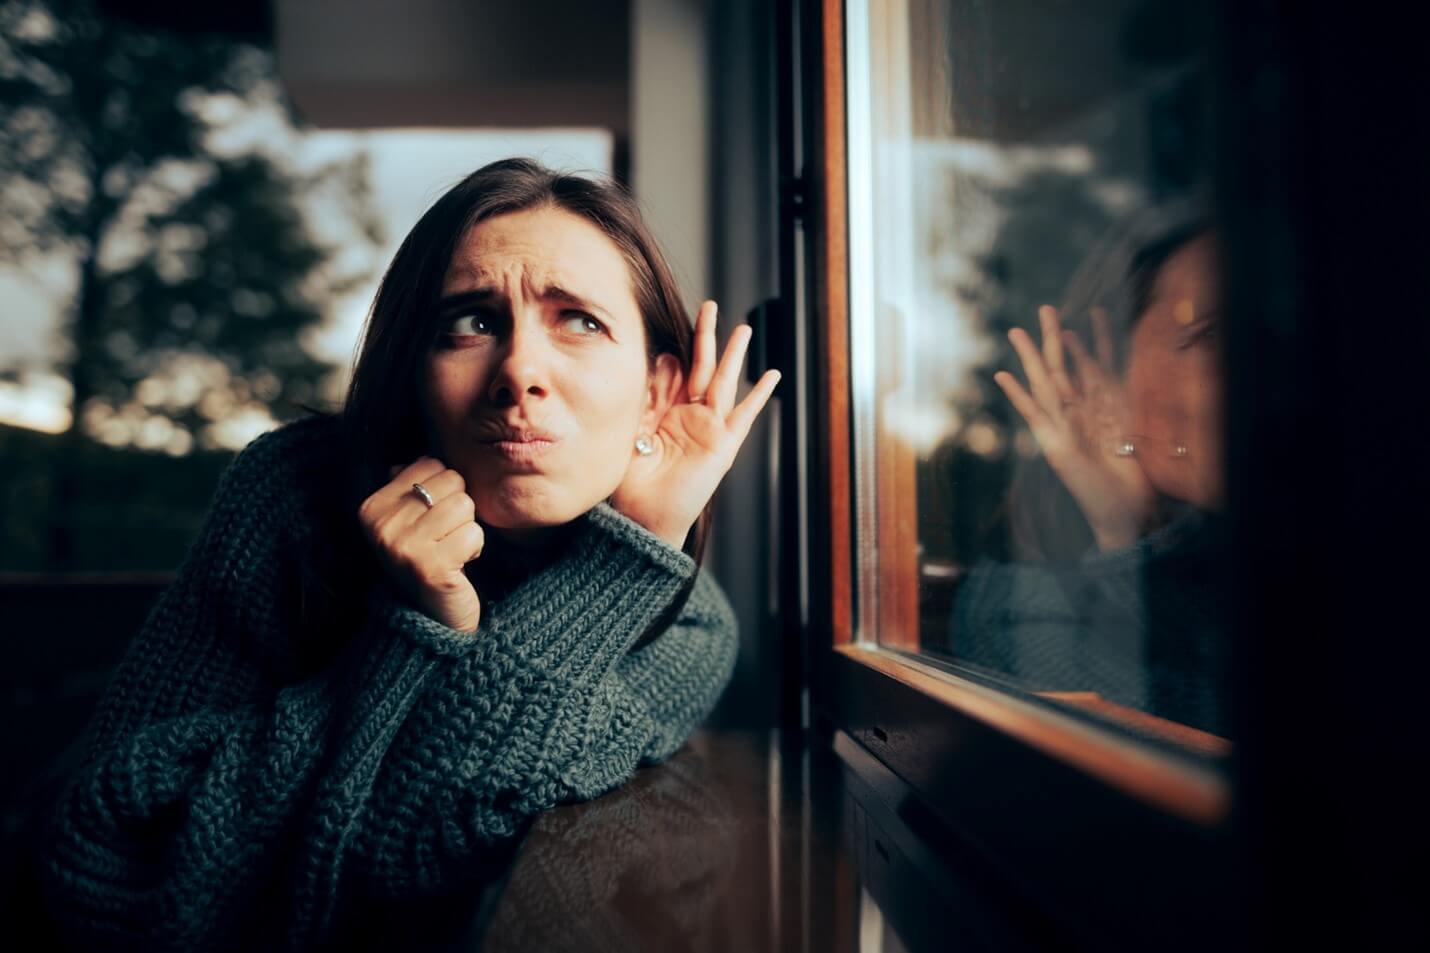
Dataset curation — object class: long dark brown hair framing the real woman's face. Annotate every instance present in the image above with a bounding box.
[343,152,711,562]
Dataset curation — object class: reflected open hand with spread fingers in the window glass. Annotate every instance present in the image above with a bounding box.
[994,305,1155,549]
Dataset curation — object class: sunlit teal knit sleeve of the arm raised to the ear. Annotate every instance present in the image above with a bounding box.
[352,507,736,896]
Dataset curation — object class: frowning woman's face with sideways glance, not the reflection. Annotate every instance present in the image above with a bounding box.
[423,206,666,531]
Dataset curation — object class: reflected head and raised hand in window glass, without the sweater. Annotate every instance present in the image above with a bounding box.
[994,226,1221,549]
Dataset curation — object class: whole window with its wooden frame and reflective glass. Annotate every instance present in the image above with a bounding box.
[804,0,1233,943]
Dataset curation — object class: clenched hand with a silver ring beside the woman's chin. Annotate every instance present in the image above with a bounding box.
[358,456,486,632]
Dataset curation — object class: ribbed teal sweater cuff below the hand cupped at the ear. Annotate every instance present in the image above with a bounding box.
[478,504,696,684]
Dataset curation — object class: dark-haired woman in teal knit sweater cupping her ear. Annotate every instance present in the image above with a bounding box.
[44,160,776,949]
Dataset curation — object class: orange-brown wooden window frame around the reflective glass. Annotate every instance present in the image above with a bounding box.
[799,0,1240,943]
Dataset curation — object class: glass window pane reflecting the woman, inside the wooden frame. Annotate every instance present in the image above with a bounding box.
[848,0,1226,751]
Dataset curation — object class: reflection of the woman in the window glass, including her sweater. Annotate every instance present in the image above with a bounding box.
[951,223,1224,731]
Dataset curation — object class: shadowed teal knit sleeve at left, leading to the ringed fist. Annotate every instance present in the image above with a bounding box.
[40,421,469,950]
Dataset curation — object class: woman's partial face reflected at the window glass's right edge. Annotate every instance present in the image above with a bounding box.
[1127,236,1223,509]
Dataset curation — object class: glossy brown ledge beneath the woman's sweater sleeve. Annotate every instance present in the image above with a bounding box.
[480,731,854,953]
